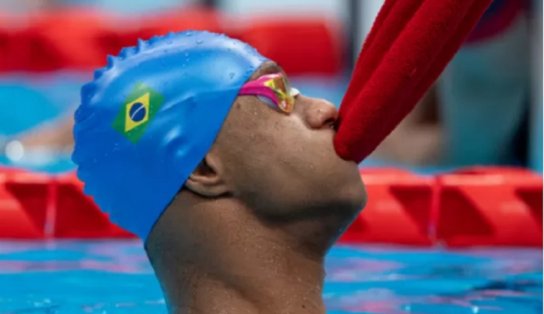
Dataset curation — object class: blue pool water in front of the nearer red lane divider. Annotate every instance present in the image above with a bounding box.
[0,241,542,314]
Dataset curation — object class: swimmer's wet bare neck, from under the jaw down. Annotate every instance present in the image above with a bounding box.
[147,197,332,314]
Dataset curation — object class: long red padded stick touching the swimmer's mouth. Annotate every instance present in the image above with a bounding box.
[334,0,491,162]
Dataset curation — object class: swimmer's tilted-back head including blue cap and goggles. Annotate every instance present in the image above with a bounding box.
[73,32,364,253]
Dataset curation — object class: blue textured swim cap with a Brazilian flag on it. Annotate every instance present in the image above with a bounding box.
[72,31,267,241]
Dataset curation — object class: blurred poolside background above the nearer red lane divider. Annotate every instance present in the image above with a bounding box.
[0,0,543,172]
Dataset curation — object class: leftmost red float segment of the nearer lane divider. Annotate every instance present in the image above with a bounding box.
[0,168,50,239]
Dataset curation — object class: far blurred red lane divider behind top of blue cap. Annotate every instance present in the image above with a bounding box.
[0,7,344,74]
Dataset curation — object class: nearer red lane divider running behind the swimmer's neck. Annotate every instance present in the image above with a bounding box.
[0,167,543,247]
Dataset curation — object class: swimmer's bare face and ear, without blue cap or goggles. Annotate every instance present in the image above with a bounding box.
[191,61,364,227]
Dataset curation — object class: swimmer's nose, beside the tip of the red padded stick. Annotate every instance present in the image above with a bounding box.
[295,95,338,129]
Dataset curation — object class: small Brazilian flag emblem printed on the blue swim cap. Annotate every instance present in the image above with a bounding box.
[113,84,163,143]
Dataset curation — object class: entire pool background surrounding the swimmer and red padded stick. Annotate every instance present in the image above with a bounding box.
[0,0,543,314]
